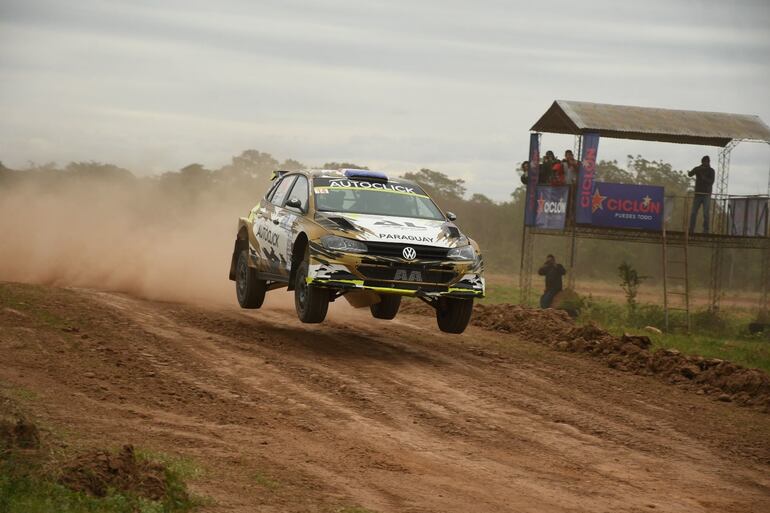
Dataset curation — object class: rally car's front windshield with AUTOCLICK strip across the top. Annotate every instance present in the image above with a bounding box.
[313,177,444,220]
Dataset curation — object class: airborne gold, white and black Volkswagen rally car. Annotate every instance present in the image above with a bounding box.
[225,169,484,333]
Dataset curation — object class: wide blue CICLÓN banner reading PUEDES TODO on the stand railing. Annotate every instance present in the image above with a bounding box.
[590,182,664,231]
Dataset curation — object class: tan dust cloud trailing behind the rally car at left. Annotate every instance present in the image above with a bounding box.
[0,181,252,304]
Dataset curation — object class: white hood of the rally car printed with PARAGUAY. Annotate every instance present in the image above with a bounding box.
[316,212,469,248]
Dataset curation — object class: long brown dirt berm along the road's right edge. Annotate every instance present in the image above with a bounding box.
[401,302,770,411]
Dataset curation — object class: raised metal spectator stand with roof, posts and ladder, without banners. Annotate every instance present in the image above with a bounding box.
[519,100,770,321]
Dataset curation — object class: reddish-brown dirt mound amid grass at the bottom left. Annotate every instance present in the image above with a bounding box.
[59,445,174,500]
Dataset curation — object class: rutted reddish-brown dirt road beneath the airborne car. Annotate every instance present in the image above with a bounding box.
[0,284,770,513]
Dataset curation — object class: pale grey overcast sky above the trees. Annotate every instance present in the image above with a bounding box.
[0,0,770,199]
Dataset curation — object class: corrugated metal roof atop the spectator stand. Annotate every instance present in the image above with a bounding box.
[531,100,770,146]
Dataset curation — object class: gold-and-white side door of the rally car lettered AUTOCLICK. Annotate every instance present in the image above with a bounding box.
[252,175,297,279]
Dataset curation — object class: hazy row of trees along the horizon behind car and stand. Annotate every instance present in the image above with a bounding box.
[0,149,758,292]
